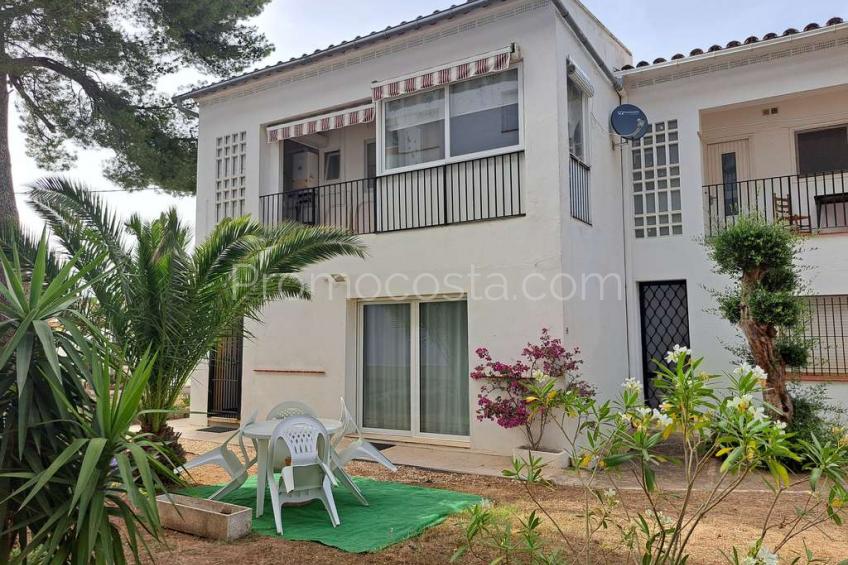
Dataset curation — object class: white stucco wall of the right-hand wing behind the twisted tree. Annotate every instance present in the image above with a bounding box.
[625,25,848,402]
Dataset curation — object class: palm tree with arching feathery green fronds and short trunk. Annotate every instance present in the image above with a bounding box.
[25,177,364,454]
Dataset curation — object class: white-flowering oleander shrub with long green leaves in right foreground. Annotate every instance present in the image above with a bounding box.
[458,346,848,565]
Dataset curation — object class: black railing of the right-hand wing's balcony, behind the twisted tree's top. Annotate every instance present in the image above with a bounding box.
[703,171,848,235]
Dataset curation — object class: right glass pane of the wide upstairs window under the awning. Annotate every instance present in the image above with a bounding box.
[450,69,518,156]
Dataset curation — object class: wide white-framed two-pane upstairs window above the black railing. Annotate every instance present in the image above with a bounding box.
[383,69,521,171]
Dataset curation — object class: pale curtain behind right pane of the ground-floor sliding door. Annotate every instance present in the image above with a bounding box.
[419,301,470,436]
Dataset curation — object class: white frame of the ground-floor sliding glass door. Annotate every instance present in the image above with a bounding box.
[356,295,474,441]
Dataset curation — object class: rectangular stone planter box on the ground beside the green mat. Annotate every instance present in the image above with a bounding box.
[156,494,251,541]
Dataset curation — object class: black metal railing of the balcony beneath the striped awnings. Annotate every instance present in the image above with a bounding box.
[259,151,524,234]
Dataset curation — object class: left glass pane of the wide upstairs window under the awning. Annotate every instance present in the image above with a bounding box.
[385,90,445,169]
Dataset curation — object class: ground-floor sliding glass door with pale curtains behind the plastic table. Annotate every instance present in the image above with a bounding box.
[360,300,470,436]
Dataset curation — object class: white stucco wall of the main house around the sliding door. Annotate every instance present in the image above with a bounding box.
[193,0,627,453]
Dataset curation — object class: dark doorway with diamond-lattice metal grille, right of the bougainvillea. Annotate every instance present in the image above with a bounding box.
[639,281,689,407]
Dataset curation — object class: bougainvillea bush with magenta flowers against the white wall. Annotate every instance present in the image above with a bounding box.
[471,329,595,449]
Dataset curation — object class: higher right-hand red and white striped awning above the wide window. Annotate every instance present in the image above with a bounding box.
[371,44,518,101]
